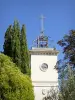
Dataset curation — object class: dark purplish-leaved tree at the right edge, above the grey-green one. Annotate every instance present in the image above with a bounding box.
[58,30,75,66]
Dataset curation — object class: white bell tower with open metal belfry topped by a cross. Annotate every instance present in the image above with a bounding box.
[30,16,59,100]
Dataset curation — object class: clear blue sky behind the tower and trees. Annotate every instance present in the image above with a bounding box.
[0,0,75,59]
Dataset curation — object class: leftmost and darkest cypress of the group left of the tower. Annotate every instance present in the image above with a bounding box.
[3,25,12,57]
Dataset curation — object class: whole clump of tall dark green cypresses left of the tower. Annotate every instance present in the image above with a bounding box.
[4,20,30,75]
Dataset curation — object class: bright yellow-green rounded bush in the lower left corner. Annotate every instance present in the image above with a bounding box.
[0,54,34,100]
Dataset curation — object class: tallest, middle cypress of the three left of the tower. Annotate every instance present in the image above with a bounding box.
[12,21,21,68]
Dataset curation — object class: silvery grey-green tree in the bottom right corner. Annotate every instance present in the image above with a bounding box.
[59,65,75,100]
